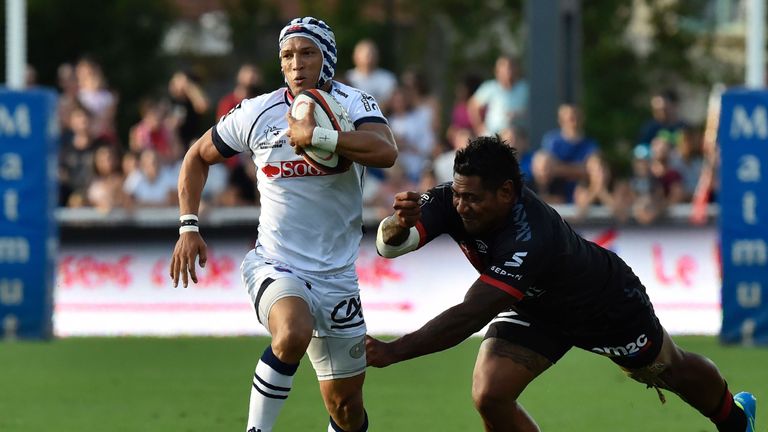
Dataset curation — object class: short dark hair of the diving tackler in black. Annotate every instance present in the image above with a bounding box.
[453,135,523,196]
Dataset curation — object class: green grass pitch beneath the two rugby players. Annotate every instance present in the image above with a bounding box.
[0,337,768,432]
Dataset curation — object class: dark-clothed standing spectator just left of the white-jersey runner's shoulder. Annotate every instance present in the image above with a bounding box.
[168,71,209,151]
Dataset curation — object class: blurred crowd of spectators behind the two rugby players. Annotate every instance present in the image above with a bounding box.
[52,40,717,224]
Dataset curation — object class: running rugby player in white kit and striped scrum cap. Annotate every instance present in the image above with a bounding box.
[170,17,397,432]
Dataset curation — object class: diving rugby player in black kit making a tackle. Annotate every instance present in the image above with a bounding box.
[366,136,755,432]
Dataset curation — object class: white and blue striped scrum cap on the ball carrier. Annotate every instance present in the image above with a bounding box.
[278,17,336,88]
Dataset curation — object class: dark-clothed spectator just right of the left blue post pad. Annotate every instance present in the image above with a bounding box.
[59,104,103,207]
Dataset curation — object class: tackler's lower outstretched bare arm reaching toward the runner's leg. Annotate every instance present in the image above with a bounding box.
[366,279,516,367]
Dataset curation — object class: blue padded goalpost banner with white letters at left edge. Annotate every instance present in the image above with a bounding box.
[0,89,59,339]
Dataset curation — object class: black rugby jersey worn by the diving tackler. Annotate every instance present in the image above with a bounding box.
[416,183,645,321]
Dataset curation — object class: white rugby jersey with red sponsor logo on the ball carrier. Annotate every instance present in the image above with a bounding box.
[212,81,387,273]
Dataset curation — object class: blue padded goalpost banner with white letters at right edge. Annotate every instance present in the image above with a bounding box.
[717,89,768,345]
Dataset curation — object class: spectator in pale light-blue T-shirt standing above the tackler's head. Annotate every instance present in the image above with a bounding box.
[469,56,528,136]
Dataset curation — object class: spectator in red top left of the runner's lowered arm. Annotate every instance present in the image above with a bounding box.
[128,99,182,165]
